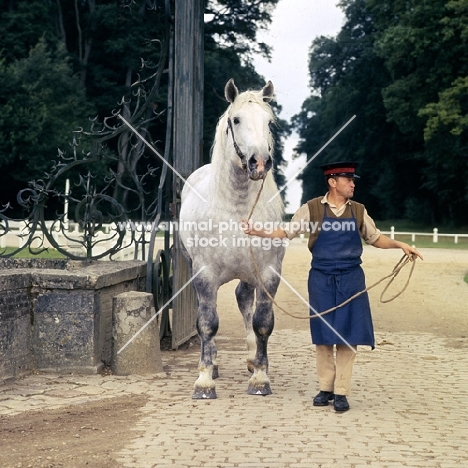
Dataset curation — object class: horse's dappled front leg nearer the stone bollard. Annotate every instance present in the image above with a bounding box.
[192,284,219,400]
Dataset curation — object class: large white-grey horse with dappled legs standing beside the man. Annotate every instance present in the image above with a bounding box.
[179,79,285,399]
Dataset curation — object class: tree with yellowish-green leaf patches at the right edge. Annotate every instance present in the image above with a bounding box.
[370,0,468,224]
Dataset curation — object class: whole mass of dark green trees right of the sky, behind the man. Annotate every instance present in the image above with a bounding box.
[293,0,468,225]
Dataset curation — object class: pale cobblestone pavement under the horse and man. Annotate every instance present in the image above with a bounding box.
[0,330,468,468]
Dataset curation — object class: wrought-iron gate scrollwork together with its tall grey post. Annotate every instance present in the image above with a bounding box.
[0,0,205,349]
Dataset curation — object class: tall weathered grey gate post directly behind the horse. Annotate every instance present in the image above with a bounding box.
[172,0,205,349]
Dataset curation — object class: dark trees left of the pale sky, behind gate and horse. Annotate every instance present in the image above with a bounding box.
[0,0,289,214]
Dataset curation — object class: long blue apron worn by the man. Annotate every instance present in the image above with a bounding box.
[308,205,375,348]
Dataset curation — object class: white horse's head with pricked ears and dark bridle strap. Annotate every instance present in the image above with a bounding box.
[224,78,274,180]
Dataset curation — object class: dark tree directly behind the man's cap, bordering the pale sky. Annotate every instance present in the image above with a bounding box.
[293,0,406,217]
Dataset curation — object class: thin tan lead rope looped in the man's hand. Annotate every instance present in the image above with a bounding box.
[247,179,417,320]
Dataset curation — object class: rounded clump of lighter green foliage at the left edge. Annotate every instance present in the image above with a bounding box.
[0,40,93,186]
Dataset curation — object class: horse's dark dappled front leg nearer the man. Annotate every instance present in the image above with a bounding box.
[247,281,277,395]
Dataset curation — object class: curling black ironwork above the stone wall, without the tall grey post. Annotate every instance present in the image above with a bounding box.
[0,0,173,344]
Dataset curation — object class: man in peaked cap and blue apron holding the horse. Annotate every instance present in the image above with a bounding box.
[243,162,422,412]
